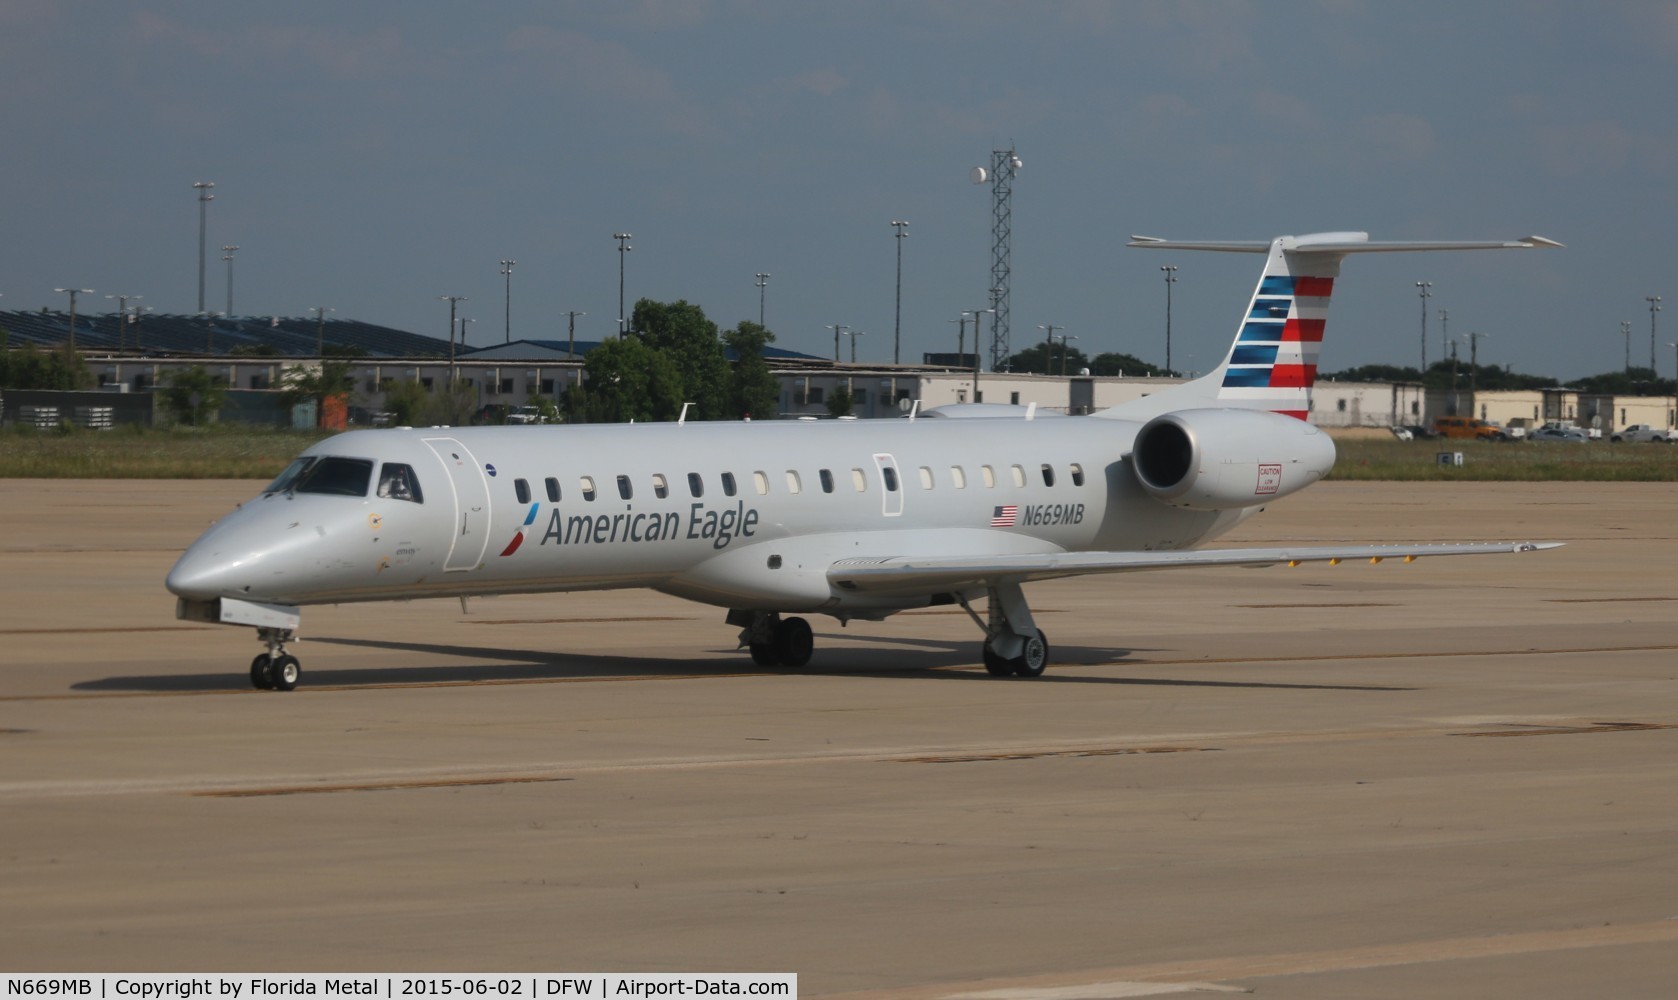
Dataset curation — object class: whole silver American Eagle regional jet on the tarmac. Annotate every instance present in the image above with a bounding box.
[166,232,1561,691]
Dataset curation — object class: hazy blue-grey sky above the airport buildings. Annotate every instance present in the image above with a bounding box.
[0,0,1678,379]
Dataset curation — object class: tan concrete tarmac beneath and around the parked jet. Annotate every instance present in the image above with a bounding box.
[0,480,1678,1000]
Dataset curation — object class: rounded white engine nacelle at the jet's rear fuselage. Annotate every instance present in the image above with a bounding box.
[1131,409,1334,510]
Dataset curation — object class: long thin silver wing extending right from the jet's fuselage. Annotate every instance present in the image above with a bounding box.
[827,542,1562,594]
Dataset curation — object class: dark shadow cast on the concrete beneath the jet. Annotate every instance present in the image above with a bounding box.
[70,634,1413,693]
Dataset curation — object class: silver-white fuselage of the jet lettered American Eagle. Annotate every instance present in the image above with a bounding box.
[168,416,1253,617]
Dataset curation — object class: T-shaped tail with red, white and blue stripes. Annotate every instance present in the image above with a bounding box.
[1102,233,1561,419]
